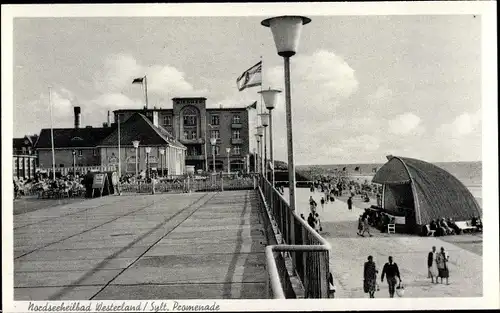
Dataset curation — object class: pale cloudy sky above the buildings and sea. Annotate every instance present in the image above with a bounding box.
[13,15,482,164]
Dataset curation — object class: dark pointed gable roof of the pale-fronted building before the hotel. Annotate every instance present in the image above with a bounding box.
[99,113,185,148]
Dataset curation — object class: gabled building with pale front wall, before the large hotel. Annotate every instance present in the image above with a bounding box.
[97,112,186,175]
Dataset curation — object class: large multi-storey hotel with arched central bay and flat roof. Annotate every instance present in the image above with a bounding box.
[113,97,250,172]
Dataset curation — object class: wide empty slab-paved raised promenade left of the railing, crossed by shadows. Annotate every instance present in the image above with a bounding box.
[14,191,267,300]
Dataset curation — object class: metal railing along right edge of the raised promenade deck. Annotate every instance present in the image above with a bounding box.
[259,177,331,299]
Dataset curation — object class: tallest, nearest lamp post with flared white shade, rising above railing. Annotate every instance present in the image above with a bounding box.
[261,16,311,214]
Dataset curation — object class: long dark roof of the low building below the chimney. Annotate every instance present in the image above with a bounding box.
[36,127,114,149]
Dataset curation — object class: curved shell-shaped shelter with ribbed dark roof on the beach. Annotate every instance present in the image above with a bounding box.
[372,156,481,225]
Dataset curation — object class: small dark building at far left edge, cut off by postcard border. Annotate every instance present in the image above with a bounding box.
[12,135,38,179]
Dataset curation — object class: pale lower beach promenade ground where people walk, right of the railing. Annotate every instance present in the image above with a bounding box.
[285,188,483,298]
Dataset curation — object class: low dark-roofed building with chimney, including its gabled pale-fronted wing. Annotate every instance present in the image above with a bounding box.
[34,107,186,175]
